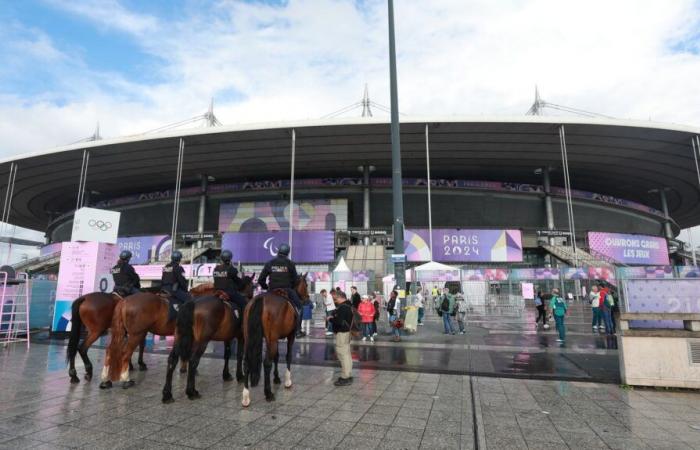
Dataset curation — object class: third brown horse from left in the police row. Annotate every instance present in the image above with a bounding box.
[163,275,255,403]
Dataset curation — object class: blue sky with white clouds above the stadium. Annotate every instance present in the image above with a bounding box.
[0,0,700,258]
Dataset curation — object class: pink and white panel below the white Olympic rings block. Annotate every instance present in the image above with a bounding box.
[51,242,119,331]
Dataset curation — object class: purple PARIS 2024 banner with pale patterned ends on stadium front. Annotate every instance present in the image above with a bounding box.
[404,228,523,262]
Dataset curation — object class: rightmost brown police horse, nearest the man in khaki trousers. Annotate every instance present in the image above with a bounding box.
[241,274,309,406]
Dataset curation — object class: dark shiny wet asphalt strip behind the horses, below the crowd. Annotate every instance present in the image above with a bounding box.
[41,303,620,383]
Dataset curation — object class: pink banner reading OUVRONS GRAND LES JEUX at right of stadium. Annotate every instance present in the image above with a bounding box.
[588,231,669,266]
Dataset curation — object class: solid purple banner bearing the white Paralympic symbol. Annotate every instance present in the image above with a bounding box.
[221,231,335,263]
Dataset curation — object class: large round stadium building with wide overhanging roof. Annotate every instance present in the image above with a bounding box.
[0,116,700,275]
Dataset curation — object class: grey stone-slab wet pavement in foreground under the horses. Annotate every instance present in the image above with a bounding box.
[0,344,700,450]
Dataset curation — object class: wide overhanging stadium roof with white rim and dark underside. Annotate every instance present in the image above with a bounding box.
[0,116,700,230]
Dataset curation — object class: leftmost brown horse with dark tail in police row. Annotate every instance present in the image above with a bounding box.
[66,292,147,383]
